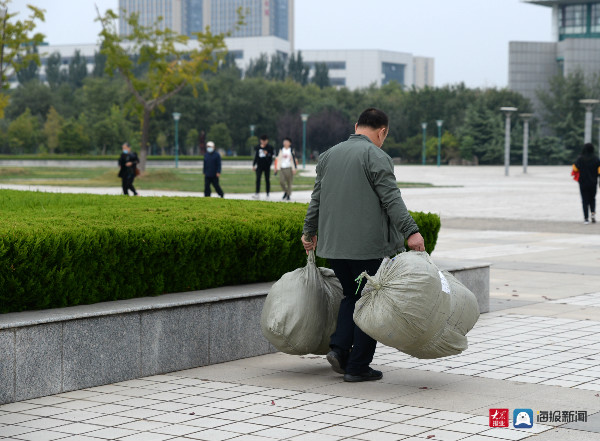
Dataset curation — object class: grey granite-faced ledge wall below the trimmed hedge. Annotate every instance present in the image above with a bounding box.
[0,260,489,404]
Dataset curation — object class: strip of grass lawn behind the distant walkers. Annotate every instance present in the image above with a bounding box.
[0,167,431,193]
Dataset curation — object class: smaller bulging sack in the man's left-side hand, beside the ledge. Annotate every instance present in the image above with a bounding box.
[260,251,343,355]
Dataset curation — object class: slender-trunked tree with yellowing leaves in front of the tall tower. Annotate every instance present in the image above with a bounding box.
[98,10,232,171]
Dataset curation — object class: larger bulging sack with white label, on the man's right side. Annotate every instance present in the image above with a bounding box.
[354,251,479,358]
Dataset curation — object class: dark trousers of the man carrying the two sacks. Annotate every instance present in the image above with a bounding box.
[329,259,382,375]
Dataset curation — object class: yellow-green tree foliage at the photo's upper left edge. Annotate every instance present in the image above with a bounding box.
[0,0,44,118]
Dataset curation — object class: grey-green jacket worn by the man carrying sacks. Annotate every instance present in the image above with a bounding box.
[303,135,419,260]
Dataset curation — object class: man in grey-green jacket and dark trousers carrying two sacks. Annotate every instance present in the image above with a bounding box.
[301,108,425,382]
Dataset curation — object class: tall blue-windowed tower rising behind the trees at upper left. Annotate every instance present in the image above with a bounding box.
[119,0,294,48]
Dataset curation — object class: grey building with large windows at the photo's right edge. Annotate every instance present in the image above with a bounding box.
[508,0,600,111]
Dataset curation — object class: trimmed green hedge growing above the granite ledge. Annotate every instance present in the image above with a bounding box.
[0,190,440,313]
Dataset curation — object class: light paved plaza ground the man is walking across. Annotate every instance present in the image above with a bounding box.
[0,166,600,441]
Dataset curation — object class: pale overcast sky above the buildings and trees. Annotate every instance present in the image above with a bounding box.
[9,0,551,87]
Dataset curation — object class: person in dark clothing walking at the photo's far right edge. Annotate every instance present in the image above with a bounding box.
[573,143,600,225]
